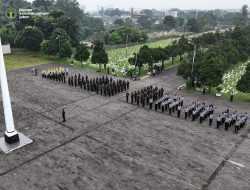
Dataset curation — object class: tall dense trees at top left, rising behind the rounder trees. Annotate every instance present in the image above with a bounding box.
[0,0,104,46]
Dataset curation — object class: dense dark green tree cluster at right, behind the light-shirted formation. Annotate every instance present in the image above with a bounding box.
[178,26,250,88]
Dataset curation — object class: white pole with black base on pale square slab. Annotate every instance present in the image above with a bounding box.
[0,39,32,153]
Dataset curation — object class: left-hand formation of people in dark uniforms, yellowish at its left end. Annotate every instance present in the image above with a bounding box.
[42,67,130,96]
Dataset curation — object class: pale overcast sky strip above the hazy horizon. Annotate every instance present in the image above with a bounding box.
[78,0,250,11]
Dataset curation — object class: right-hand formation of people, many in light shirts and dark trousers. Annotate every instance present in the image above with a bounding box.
[126,86,248,133]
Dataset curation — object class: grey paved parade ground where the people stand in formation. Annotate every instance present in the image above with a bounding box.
[0,65,250,190]
